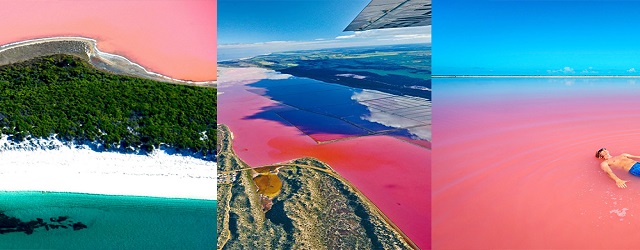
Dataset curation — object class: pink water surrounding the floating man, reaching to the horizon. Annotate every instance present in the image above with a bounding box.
[432,79,640,249]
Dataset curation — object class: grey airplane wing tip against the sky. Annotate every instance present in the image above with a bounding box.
[344,0,431,31]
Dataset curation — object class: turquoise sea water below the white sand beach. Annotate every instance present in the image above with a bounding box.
[0,192,217,249]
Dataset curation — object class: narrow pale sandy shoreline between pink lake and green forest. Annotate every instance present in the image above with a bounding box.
[0,36,217,87]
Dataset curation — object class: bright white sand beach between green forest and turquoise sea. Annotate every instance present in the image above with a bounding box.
[0,135,216,200]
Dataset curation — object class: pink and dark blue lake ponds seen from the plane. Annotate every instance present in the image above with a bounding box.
[218,67,431,248]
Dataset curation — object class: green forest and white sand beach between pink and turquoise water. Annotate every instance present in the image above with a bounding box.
[0,48,216,200]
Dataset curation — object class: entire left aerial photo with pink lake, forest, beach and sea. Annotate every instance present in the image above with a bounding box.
[0,0,217,245]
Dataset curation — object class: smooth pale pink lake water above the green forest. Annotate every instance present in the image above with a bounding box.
[0,0,216,81]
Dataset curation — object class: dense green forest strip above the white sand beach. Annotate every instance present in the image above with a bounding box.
[0,55,217,155]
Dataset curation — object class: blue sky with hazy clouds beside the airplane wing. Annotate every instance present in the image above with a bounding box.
[218,0,431,61]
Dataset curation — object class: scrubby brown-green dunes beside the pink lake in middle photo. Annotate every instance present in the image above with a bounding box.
[218,125,418,249]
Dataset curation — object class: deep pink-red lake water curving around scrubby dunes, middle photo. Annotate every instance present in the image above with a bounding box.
[218,69,431,249]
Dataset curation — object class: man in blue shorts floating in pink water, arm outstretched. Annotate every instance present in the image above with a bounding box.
[596,148,640,188]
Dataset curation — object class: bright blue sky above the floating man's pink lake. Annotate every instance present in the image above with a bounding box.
[432,0,640,75]
